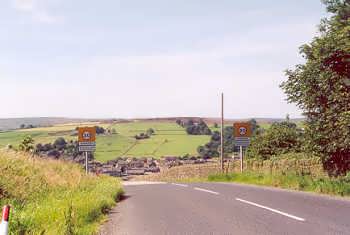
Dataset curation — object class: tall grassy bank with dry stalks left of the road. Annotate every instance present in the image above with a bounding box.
[0,151,122,235]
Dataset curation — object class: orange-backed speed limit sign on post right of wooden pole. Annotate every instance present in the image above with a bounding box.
[233,122,252,173]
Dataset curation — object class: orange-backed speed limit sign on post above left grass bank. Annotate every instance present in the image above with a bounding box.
[78,127,96,174]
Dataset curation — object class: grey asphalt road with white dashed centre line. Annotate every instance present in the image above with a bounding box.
[101,183,350,235]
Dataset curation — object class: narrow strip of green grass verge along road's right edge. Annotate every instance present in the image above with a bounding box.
[208,172,350,196]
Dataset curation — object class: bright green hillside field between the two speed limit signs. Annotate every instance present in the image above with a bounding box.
[95,121,210,161]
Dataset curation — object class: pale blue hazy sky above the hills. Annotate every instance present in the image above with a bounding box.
[0,0,327,118]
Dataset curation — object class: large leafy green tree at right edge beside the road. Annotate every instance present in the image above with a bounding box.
[281,0,350,175]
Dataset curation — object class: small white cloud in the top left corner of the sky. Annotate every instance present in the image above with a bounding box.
[12,0,62,24]
